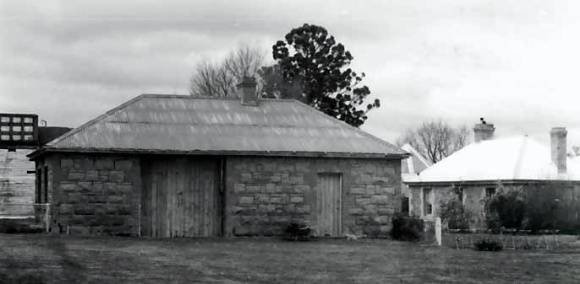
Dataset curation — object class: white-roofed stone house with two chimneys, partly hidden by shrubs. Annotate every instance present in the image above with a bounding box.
[405,123,580,228]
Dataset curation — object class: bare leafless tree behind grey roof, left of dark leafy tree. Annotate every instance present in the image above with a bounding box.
[189,45,264,97]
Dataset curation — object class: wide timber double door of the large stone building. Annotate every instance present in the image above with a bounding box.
[141,158,222,237]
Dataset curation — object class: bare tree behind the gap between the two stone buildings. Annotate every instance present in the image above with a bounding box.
[397,120,471,163]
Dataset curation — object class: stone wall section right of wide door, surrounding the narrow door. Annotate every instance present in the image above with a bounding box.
[225,157,401,237]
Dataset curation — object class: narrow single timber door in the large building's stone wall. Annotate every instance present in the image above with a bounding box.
[316,173,342,237]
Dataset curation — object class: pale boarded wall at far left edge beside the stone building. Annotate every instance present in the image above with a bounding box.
[0,149,35,217]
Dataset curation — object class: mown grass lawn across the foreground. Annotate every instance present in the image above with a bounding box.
[0,234,580,283]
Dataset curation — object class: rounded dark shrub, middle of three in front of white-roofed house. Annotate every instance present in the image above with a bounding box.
[485,191,526,232]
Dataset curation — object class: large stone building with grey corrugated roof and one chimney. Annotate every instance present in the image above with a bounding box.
[31,82,407,237]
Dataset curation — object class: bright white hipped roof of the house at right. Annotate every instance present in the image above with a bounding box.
[416,136,580,182]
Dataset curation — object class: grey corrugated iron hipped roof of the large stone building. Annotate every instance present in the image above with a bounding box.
[32,95,406,158]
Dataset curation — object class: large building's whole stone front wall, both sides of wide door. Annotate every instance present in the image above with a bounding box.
[37,154,401,237]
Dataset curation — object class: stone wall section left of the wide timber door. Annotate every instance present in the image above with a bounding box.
[39,155,141,235]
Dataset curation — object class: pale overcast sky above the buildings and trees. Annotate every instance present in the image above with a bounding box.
[0,0,580,149]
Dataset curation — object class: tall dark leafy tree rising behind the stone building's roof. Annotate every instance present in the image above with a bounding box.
[272,24,380,127]
